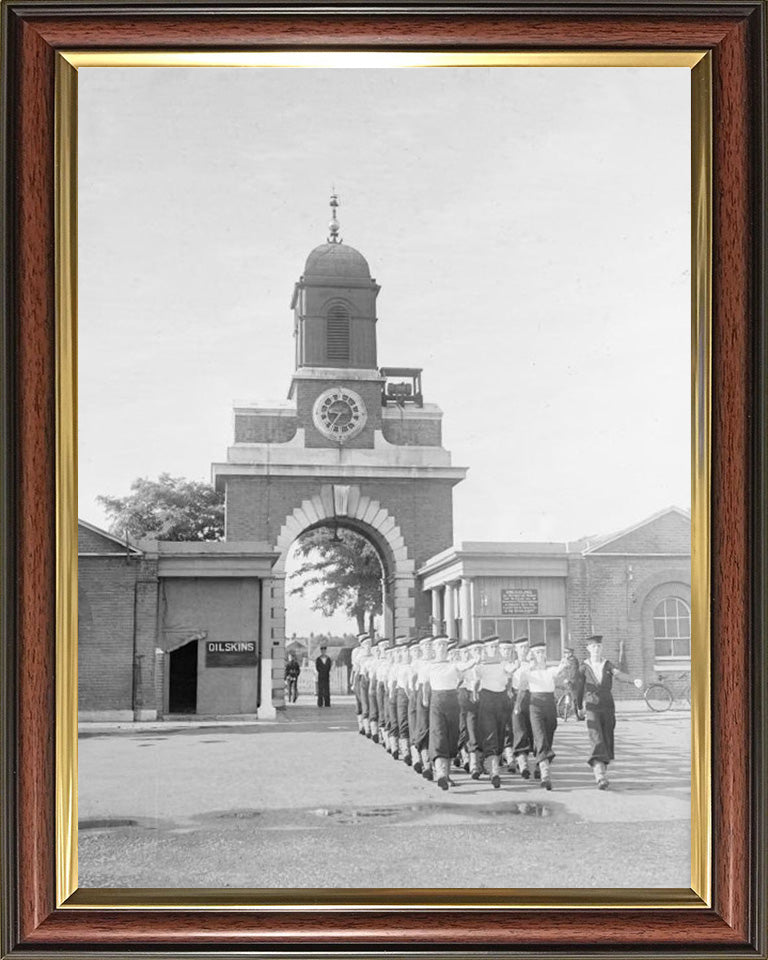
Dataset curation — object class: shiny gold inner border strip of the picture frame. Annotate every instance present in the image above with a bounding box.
[55,50,712,911]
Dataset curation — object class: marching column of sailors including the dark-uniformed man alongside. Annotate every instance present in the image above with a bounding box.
[352,634,642,790]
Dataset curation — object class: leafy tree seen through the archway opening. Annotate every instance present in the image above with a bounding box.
[290,527,382,633]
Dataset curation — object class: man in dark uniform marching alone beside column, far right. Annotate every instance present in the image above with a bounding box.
[576,635,643,790]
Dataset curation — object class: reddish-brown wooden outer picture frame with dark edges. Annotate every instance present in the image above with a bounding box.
[0,0,768,957]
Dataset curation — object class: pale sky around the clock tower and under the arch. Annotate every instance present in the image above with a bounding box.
[78,67,690,634]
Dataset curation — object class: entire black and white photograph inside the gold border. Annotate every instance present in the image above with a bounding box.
[77,56,695,890]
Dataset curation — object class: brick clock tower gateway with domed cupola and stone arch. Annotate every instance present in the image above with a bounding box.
[213,196,466,713]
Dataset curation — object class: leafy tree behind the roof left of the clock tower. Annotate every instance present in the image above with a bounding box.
[97,473,224,540]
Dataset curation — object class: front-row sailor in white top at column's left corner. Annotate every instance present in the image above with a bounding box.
[424,637,473,790]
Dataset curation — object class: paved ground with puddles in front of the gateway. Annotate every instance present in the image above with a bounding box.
[79,701,690,887]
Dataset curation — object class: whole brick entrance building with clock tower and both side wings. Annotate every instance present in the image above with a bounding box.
[78,197,690,720]
